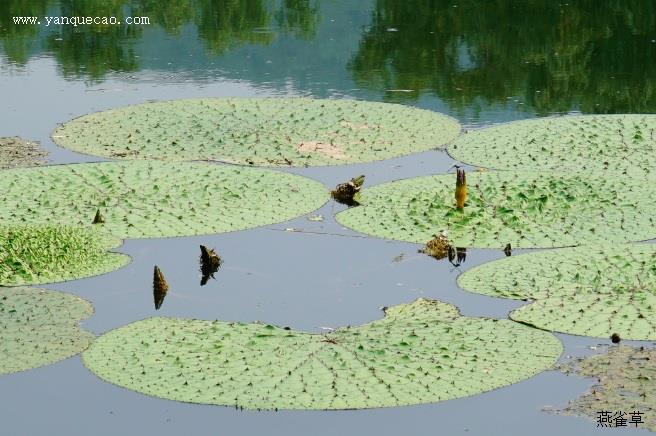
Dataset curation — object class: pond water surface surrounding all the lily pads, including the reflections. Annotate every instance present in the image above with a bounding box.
[0,0,656,435]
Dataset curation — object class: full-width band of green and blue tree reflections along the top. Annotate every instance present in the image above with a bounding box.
[0,0,656,118]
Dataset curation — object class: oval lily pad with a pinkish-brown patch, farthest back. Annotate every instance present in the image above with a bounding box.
[52,98,460,166]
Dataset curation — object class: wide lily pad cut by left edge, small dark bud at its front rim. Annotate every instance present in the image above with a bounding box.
[0,161,328,238]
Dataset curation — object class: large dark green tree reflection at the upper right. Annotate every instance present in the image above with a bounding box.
[349,0,656,114]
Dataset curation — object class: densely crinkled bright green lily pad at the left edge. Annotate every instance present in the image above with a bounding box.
[0,226,130,286]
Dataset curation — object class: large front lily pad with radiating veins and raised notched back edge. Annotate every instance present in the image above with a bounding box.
[83,299,562,409]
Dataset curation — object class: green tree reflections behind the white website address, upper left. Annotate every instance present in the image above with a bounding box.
[0,0,319,80]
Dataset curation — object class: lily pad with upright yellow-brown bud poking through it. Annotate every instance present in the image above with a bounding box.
[337,172,656,248]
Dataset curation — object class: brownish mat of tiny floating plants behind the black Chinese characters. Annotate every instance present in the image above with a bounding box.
[560,346,656,431]
